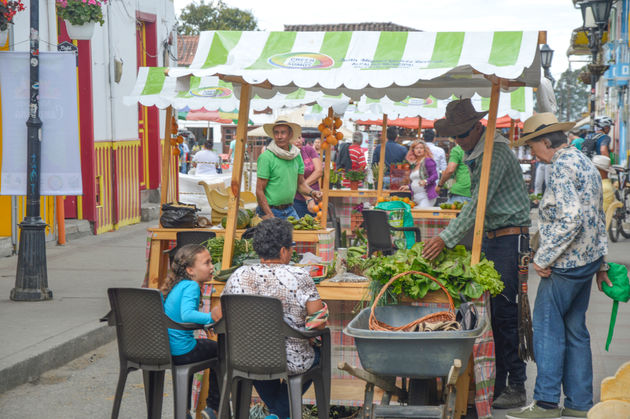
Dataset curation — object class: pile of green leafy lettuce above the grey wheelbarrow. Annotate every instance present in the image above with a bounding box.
[365,243,504,302]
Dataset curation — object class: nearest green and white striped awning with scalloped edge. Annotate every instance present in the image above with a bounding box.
[169,31,540,101]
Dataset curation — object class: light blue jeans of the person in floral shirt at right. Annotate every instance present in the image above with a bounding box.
[533,259,601,410]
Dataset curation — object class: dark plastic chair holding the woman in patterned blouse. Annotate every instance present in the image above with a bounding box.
[215,295,330,419]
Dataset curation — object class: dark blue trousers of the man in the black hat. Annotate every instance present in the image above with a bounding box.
[482,235,527,395]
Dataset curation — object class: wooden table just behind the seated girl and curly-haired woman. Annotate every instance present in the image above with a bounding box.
[147,227,334,288]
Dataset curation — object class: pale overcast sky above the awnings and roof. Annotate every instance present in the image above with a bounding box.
[174,0,584,80]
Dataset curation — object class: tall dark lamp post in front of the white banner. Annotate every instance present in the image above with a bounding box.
[10,1,52,301]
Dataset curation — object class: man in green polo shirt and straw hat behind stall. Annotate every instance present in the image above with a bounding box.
[256,119,322,219]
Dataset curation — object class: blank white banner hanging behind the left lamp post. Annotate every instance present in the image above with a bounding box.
[0,51,83,195]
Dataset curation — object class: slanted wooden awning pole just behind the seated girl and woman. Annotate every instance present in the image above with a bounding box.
[221,83,252,269]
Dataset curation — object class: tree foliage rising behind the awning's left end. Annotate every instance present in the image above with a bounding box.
[179,0,258,35]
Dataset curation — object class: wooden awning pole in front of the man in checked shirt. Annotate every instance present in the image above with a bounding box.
[470,80,500,265]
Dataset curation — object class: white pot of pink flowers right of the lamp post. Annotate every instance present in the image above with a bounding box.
[56,0,107,40]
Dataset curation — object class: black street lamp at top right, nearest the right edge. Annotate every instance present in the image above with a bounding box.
[580,0,612,132]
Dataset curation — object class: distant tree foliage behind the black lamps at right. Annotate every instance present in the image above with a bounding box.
[554,69,590,121]
